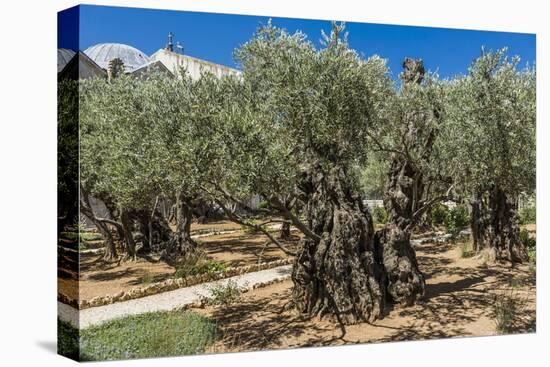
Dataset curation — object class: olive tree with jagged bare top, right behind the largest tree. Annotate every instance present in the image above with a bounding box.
[368,59,445,304]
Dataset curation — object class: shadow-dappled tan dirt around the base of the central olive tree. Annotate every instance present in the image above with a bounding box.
[196,239,536,353]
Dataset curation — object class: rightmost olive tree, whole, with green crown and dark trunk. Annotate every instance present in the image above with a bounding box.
[441,49,536,261]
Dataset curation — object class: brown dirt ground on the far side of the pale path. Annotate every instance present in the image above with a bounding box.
[58,221,299,300]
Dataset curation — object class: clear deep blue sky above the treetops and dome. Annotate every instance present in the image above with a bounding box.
[58,5,536,78]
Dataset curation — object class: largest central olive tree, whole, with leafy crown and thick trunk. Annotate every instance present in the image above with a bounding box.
[235,23,393,324]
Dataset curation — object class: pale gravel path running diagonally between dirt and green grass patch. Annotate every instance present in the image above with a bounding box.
[57,265,292,328]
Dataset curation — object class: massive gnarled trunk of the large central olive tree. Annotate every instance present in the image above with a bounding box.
[292,166,385,324]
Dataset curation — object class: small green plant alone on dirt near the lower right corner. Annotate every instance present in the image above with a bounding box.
[494,289,525,334]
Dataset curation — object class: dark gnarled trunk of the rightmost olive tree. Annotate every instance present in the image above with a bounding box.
[470,185,528,263]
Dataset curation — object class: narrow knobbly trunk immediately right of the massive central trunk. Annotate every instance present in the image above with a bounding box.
[375,156,426,305]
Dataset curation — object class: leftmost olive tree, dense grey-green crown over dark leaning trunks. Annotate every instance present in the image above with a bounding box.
[80,74,202,257]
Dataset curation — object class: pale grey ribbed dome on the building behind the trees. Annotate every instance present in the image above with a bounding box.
[84,43,150,71]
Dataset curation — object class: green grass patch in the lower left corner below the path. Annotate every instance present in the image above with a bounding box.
[58,311,218,361]
